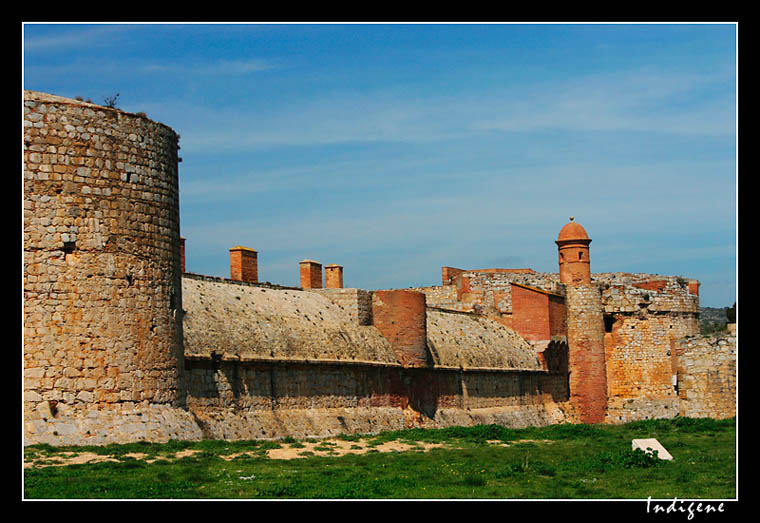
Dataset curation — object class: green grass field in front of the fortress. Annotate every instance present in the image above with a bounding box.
[24,418,736,499]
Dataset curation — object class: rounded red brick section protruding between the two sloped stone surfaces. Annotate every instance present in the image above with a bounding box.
[372,290,428,367]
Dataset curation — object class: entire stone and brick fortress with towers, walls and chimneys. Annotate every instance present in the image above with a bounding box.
[23,91,737,445]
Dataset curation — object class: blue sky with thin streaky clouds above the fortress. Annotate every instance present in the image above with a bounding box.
[23,23,737,307]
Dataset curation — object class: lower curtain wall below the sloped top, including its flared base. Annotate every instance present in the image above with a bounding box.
[187,358,576,439]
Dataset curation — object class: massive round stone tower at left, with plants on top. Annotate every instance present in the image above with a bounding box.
[23,91,200,444]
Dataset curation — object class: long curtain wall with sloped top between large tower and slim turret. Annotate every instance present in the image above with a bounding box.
[178,274,575,439]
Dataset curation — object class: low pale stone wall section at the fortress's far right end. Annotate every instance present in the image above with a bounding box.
[675,333,738,419]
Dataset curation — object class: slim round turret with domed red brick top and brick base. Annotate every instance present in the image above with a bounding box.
[556,217,607,423]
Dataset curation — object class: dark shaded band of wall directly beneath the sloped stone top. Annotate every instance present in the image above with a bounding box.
[181,356,569,419]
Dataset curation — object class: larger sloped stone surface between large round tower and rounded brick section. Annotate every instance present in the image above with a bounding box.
[182,274,396,363]
